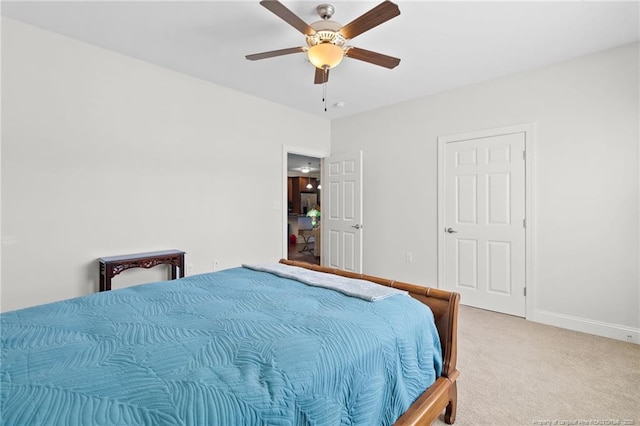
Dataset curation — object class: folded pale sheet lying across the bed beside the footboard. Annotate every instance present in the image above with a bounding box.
[242,263,408,302]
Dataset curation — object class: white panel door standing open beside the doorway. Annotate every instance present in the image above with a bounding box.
[322,151,363,272]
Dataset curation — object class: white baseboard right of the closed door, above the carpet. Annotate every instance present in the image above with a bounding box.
[532,310,640,344]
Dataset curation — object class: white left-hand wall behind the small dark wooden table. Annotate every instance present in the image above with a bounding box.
[2,18,330,311]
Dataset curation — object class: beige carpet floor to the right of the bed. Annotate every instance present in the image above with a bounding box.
[434,306,640,426]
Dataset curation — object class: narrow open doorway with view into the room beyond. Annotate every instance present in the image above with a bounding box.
[285,152,322,265]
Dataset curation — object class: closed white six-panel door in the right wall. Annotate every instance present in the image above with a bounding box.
[439,132,526,317]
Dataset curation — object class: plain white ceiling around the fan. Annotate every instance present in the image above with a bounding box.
[2,0,640,119]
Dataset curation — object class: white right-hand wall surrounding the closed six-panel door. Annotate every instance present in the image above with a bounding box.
[331,44,640,342]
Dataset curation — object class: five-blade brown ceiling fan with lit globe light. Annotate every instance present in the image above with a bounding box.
[246,0,400,84]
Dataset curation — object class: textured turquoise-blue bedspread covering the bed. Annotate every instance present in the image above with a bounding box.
[0,268,442,426]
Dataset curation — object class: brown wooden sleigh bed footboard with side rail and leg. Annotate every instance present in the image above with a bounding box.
[280,259,460,426]
